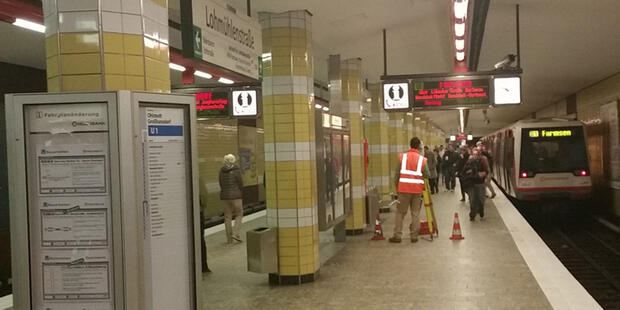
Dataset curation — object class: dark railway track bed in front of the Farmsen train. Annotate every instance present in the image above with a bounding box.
[534,217,620,310]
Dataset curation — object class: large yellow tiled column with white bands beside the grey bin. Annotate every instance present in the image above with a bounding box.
[259,11,320,284]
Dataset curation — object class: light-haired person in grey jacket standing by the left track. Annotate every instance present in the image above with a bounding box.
[219,154,243,243]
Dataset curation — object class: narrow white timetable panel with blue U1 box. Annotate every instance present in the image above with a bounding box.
[140,105,193,310]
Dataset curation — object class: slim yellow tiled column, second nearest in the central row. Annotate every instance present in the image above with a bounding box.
[340,58,366,234]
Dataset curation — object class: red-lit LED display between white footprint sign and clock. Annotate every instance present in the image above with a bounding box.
[413,78,490,109]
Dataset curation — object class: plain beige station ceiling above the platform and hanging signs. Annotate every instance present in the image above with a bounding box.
[0,0,620,135]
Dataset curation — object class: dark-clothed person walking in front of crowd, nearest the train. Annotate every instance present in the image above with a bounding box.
[461,148,489,221]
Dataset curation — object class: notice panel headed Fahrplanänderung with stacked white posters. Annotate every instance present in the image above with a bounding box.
[24,102,115,310]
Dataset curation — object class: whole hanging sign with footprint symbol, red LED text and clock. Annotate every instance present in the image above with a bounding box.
[381,70,522,112]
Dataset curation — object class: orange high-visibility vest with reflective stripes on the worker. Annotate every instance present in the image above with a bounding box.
[398,149,426,194]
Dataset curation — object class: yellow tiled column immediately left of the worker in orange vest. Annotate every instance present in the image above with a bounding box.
[365,84,390,198]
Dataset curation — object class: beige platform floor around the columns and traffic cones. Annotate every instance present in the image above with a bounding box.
[203,180,568,310]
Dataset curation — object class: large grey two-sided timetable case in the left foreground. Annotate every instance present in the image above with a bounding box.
[6,91,201,310]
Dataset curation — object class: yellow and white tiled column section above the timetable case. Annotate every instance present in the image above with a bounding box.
[43,0,170,92]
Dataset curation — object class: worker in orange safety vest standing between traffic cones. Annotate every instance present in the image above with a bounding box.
[388,137,430,243]
